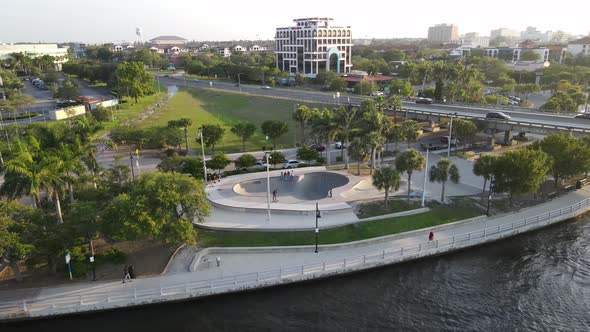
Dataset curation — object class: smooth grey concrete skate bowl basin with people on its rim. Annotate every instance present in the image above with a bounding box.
[233,172,350,201]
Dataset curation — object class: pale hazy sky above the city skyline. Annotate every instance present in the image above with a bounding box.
[0,0,590,43]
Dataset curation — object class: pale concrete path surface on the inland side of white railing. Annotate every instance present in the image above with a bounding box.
[0,184,590,314]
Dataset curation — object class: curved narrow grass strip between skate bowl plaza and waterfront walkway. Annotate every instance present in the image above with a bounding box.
[198,201,482,247]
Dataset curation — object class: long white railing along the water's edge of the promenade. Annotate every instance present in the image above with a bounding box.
[0,198,590,319]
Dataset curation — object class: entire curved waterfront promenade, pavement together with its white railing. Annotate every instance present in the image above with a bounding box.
[0,188,590,320]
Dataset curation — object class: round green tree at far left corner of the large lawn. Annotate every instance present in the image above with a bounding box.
[117,62,156,103]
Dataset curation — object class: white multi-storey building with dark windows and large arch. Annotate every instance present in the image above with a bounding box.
[275,17,352,77]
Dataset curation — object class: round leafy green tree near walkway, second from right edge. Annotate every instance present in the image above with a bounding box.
[493,149,549,205]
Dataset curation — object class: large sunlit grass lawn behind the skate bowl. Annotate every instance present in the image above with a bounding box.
[139,88,332,153]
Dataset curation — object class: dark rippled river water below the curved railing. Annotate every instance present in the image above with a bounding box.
[0,216,590,332]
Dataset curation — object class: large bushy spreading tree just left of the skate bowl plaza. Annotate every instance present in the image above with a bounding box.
[103,173,210,244]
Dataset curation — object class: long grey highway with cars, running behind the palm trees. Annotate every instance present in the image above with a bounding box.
[159,76,590,130]
